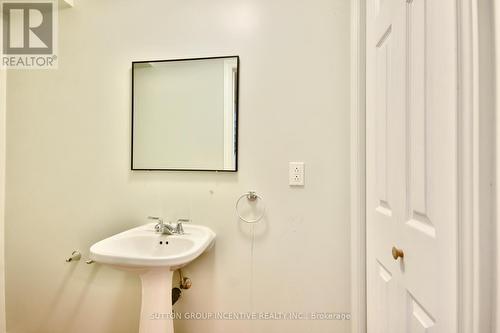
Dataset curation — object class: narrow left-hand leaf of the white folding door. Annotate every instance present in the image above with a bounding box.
[367,0,405,333]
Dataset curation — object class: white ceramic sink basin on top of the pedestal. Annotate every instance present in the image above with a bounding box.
[90,223,215,269]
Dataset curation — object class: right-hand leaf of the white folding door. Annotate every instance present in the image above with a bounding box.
[398,0,458,332]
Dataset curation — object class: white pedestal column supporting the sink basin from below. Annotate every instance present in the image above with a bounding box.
[139,267,174,333]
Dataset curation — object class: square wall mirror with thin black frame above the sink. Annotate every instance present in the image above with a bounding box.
[132,56,239,171]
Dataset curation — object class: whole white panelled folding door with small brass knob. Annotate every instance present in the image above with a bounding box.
[366,0,458,333]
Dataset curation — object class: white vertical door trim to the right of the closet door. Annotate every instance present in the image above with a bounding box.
[457,0,496,333]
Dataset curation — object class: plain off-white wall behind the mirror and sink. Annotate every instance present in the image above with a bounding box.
[6,0,350,333]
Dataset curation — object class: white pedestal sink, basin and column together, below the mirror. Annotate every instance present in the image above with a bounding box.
[90,223,215,333]
